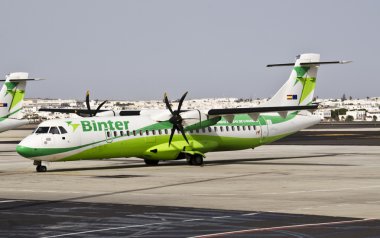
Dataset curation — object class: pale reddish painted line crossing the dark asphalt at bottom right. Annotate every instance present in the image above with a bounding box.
[190,218,377,238]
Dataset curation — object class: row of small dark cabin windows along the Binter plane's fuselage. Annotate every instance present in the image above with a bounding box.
[107,126,256,137]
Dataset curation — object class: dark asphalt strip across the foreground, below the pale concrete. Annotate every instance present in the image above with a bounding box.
[0,200,380,237]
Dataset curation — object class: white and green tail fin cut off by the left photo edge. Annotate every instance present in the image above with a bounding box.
[0,72,32,119]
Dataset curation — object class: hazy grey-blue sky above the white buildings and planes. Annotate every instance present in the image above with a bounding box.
[0,0,380,100]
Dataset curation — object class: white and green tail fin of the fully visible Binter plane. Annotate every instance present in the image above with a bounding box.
[266,54,322,106]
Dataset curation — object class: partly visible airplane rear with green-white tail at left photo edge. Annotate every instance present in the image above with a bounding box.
[0,72,40,132]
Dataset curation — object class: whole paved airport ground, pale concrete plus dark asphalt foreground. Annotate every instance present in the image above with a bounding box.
[0,129,380,237]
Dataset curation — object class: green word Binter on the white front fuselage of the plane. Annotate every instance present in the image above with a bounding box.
[80,120,129,132]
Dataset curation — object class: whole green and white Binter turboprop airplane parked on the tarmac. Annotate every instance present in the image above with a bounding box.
[16,54,346,172]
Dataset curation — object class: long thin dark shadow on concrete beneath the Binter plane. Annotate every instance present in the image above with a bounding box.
[48,153,354,173]
